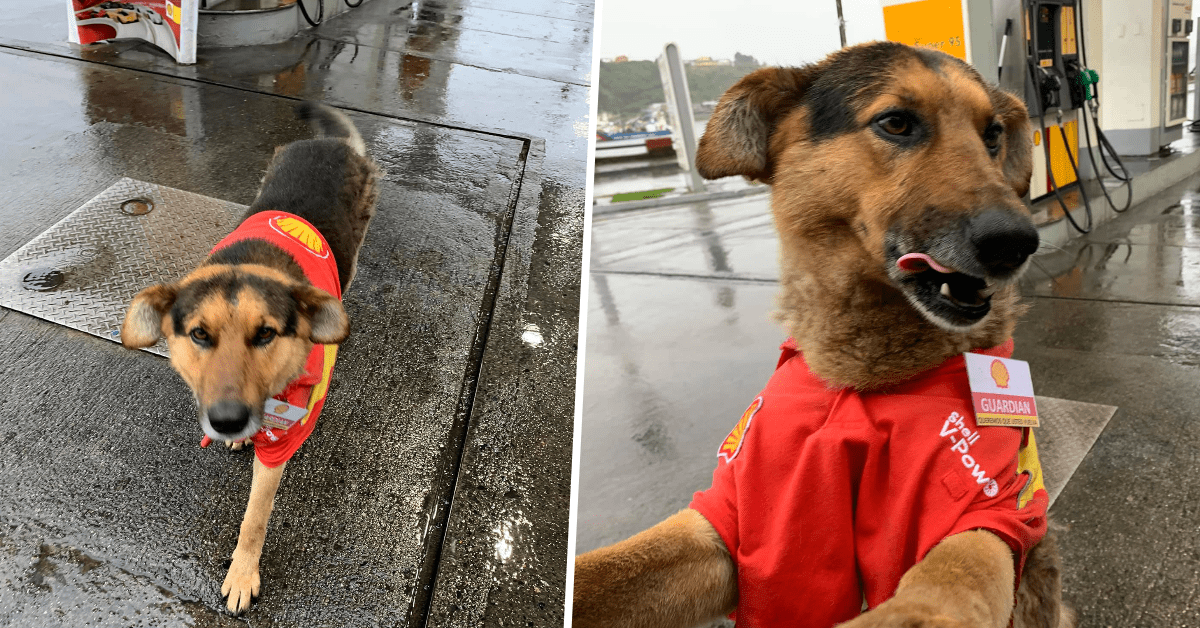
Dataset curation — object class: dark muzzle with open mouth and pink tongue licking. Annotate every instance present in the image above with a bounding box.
[888,209,1038,331]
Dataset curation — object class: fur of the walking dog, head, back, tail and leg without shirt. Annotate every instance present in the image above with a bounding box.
[121,103,378,614]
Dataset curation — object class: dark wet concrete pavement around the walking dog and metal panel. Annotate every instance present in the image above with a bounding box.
[0,0,592,627]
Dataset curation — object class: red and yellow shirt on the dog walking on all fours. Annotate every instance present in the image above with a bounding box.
[204,211,342,468]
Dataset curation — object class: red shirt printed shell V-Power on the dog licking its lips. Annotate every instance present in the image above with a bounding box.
[691,340,1049,628]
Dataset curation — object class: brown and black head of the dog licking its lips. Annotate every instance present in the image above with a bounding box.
[696,42,1038,331]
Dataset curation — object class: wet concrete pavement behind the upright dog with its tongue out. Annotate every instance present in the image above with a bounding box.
[576,175,1200,627]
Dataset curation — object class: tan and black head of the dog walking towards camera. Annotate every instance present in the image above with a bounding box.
[121,264,349,441]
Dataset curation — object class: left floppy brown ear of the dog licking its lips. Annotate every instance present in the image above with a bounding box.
[696,66,817,183]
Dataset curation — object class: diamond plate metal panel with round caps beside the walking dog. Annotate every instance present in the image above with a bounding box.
[0,179,246,355]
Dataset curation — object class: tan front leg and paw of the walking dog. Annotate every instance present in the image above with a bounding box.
[221,456,287,614]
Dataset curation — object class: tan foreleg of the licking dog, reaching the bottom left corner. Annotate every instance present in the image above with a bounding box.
[571,510,738,628]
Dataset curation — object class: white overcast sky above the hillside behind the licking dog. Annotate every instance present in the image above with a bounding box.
[600,0,883,65]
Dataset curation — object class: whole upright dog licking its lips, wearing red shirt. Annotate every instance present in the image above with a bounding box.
[572,42,1073,628]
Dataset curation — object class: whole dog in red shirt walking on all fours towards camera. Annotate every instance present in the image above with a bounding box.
[121,102,378,615]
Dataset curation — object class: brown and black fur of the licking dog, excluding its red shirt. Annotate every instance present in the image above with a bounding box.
[572,42,1073,628]
